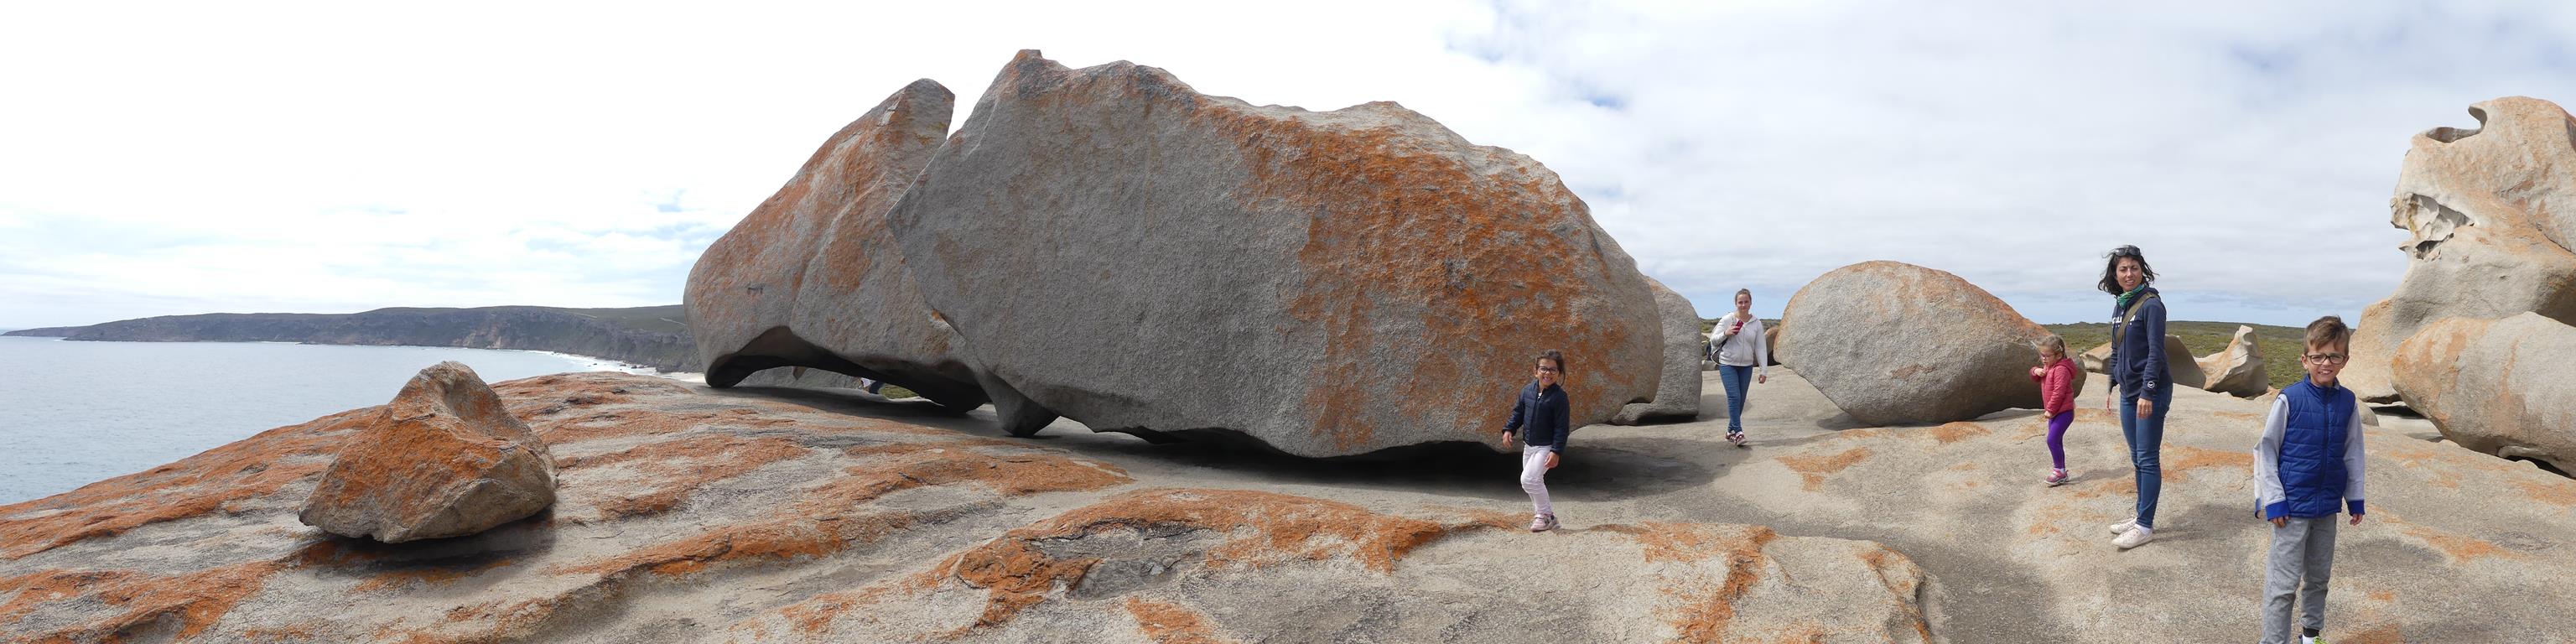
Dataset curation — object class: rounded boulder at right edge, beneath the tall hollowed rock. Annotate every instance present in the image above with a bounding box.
[2393,312,2576,471]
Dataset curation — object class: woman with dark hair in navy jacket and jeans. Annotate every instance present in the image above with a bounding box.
[2100,245,2174,548]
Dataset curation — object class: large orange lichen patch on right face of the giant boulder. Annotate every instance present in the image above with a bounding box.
[1190,96,1661,451]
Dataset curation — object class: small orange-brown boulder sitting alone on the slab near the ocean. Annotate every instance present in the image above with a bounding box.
[296,363,553,543]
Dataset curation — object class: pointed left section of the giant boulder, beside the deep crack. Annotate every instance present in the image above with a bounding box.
[685,80,984,407]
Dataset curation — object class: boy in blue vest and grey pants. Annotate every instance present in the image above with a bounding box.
[2254,314,2362,644]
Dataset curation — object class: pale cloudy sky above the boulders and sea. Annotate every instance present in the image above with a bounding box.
[0,0,2576,327]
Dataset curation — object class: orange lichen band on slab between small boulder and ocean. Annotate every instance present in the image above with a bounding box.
[0,407,384,559]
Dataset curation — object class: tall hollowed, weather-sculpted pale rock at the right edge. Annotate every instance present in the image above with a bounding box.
[2341,96,2576,402]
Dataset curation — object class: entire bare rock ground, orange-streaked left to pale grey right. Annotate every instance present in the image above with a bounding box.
[0,368,2576,644]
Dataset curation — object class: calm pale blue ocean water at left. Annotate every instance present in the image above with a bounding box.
[0,337,664,505]
